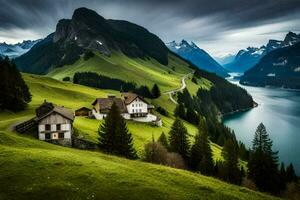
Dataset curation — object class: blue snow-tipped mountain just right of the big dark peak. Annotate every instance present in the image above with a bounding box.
[166,40,229,77]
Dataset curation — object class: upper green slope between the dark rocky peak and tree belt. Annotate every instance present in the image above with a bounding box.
[48,52,192,90]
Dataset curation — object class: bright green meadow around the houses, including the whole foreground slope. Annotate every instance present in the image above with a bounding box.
[0,74,275,200]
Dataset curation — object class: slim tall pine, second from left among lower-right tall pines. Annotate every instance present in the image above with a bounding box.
[190,118,214,175]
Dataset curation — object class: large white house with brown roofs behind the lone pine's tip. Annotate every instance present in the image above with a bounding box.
[92,93,162,126]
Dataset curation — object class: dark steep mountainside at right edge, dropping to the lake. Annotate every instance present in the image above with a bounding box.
[240,42,300,89]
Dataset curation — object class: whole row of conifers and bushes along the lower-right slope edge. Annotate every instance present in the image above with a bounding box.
[144,117,298,194]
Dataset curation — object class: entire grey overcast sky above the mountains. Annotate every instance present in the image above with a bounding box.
[0,0,300,56]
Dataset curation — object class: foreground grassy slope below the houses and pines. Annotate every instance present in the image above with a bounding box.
[0,131,272,200]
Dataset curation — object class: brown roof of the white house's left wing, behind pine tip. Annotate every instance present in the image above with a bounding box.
[92,97,127,113]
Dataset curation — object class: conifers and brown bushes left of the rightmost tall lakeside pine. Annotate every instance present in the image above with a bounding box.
[144,118,245,184]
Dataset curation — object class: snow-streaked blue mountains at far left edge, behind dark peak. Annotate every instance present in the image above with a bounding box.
[0,40,41,58]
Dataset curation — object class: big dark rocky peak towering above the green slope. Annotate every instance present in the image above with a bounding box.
[16,8,168,74]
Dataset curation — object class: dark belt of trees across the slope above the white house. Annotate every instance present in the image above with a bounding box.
[73,72,161,99]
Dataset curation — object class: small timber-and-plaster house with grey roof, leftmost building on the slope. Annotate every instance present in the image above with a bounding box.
[35,101,74,146]
